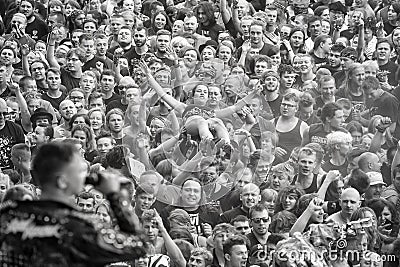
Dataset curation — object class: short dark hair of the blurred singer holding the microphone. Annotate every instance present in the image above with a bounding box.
[32,142,79,186]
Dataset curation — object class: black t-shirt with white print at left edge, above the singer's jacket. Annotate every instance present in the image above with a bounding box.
[0,121,25,170]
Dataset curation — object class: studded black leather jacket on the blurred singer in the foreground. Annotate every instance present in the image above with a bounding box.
[0,193,146,267]
